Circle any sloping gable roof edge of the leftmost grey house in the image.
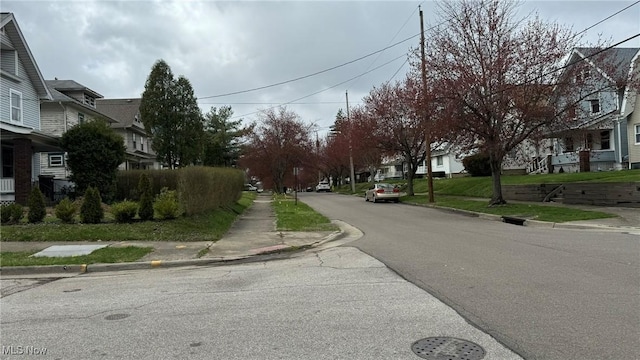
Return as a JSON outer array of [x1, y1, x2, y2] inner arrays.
[[0, 12, 51, 100]]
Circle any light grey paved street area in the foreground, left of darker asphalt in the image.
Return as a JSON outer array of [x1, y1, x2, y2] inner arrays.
[[0, 247, 519, 360]]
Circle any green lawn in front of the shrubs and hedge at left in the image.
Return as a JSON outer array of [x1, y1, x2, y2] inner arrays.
[[0, 192, 256, 241]]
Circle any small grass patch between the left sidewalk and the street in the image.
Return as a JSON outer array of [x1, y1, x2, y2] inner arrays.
[[272, 195, 338, 231]]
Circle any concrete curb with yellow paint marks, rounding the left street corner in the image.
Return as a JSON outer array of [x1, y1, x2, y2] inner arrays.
[[0, 230, 344, 276]]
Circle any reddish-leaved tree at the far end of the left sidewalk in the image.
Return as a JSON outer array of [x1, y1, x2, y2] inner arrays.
[[242, 107, 313, 193]]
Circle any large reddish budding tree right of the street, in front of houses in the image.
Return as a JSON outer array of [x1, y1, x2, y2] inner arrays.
[[426, 0, 578, 205]]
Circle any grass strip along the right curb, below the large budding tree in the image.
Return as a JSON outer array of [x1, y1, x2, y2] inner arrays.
[[401, 195, 615, 223]]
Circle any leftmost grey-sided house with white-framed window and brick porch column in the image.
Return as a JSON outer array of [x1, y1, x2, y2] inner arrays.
[[0, 13, 61, 205]]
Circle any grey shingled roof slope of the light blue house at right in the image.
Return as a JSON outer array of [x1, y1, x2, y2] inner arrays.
[[575, 47, 640, 82]]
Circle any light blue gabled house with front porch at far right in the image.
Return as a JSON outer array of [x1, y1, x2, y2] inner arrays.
[[528, 48, 640, 173]]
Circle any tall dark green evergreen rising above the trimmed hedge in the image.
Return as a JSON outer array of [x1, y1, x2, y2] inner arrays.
[[140, 60, 204, 168]]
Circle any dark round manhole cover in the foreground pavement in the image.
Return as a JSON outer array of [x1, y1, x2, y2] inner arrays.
[[411, 337, 485, 360]]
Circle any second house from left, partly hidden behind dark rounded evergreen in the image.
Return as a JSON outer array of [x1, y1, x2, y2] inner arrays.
[[38, 79, 116, 191]]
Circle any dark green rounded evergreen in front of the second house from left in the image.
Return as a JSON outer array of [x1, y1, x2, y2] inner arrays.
[[60, 120, 125, 201]]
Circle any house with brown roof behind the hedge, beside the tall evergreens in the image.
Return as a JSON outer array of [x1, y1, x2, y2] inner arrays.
[[96, 98, 161, 170]]
